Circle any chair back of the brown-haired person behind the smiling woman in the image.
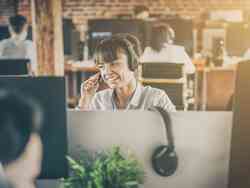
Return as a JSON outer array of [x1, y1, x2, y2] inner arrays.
[[139, 62, 187, 110]]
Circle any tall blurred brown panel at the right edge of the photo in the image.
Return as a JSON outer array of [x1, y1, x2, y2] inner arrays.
[[228, 61, 250, 188]]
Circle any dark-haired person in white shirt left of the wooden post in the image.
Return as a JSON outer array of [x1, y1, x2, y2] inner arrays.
[[0, 15, 37, 74]]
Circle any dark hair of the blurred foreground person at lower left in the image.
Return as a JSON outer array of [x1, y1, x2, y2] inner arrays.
[[0, 89, 42, 164]]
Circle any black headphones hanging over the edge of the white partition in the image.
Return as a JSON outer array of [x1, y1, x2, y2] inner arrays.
[[150, 107, 178, 177]]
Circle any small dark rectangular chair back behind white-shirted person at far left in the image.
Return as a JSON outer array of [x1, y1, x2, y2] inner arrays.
[[0, 59, 30, 76]]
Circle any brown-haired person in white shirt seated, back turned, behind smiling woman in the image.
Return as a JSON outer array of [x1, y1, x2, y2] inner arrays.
[[140, 24, 195, 74]]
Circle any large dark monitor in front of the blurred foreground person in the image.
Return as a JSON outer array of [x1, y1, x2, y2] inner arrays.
[[0, 77, 68, 179]]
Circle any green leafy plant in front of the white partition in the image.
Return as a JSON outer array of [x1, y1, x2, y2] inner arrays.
[[63, 147, 144, 188]]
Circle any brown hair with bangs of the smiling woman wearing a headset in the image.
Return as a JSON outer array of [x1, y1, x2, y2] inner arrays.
[[94, 36, 138, 71]]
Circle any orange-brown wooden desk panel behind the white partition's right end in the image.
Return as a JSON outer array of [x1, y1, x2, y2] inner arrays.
[[196, 67, 236, 110]]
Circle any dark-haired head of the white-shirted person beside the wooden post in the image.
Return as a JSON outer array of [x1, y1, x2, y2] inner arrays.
[[9, 15, 28, 41]]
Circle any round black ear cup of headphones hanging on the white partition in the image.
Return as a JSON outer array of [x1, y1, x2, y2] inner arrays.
[[152, 145, 178, 177]]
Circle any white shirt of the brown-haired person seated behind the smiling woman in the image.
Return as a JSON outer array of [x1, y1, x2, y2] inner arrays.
[[140, 43, 195, 74]]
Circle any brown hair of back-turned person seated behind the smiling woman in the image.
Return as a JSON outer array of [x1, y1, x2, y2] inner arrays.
[[150, 24, 174, 52]]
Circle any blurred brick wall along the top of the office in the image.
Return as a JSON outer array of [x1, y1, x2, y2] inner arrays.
[[0, 0, 250, 38]]
